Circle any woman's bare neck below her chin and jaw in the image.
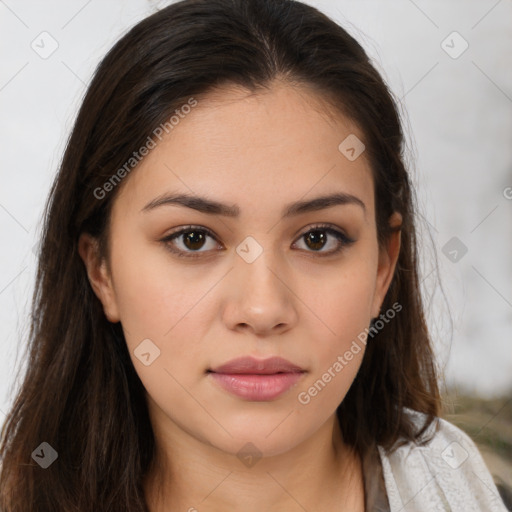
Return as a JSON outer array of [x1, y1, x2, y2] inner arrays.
[[145, 415, 364, 512]]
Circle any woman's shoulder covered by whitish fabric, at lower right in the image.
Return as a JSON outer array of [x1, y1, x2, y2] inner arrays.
[[379, 409, 507, 512]]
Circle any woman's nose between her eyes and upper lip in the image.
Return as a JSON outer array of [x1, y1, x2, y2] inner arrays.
[[223, 247, 298, 336]]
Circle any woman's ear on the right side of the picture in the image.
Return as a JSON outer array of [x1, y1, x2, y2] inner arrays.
[[372, 212, 402, 318]]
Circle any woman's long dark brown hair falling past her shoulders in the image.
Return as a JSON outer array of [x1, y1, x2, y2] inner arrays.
[[0, 0, 439, 512]]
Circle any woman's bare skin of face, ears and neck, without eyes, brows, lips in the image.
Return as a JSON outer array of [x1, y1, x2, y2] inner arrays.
[[79, 82, 400, 512]]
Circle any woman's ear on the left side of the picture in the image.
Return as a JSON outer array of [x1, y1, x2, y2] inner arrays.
[[78, 233, 119, 323]]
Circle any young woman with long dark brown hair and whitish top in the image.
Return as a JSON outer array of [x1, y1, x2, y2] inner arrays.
[[0, 0, 505, 512]]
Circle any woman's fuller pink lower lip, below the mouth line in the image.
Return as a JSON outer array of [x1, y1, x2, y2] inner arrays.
[[209, 372, 304, 402]]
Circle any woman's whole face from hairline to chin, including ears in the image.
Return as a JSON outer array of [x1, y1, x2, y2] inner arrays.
[[80, 85, 399, 455]]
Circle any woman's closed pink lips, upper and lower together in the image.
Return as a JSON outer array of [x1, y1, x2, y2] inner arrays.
[[208, 357, 305, 401]]
